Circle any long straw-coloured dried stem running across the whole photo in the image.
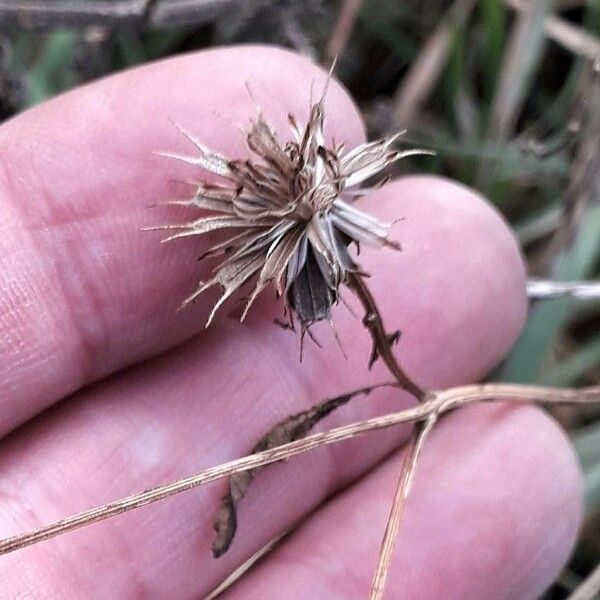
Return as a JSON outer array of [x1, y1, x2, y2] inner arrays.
[[0, 383, 600, 554]]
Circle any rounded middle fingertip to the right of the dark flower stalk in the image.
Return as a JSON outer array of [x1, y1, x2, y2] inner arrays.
[[361, 176, 527, 386]]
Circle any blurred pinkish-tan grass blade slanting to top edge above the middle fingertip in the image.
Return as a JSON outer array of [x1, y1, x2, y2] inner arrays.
[[393, 0, 475, 127]]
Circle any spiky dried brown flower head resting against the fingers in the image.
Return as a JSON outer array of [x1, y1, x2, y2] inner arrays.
[[157, 82, 421, 331]]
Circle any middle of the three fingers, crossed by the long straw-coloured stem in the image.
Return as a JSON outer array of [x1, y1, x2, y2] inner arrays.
[[0, 177, 525, 597]]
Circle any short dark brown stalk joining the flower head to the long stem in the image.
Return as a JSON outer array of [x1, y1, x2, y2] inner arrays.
[[348, 273, 427, 401]]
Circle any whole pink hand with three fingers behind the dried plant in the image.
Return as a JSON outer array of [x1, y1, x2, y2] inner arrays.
[[0, 47, 581, 600]]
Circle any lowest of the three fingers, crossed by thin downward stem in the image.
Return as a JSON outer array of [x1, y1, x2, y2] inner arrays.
[[224, 406, 582, 600]]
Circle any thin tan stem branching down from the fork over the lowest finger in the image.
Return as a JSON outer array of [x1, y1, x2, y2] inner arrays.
[[369, 412, 438, 600]]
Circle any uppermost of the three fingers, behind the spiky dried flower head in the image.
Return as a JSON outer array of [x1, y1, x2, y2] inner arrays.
[[0, 47, 363, 435]]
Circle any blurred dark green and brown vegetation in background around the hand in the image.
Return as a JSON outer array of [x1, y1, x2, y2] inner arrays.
[[0, 0, 600, 600]]
